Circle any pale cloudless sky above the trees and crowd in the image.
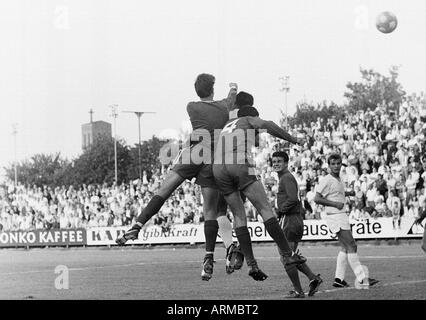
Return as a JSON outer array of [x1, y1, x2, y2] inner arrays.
[[0, 0, 426, 180]]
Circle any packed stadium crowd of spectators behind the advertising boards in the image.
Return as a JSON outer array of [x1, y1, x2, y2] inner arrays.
[[0, 93, 426, 231]]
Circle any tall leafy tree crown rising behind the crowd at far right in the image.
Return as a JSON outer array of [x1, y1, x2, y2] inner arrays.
[[344, 66, 406, 112]]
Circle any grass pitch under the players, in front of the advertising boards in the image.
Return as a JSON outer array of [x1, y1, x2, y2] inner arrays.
[[0, 240, 426, 301]]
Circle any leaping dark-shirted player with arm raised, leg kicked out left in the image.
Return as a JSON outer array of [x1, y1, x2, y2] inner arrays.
[[116, 73, 237, 281]]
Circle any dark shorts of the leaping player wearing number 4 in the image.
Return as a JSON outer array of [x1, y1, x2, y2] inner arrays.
[[213, 164, 258, 195]]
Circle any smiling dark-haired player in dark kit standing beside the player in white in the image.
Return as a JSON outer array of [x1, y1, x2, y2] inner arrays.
[[272, 151, 322, 298]]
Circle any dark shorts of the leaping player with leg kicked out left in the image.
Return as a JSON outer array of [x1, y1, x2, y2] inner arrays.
[[172, 149, 218, 189]]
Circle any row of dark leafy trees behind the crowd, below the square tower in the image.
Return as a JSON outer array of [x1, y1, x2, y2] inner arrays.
[[4, 136, 167, 186]]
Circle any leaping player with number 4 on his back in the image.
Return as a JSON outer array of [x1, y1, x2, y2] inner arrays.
[[213, 102, 306, 281]]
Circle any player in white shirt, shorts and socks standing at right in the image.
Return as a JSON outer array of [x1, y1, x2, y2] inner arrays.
[[314, 153, 379, 289]]
